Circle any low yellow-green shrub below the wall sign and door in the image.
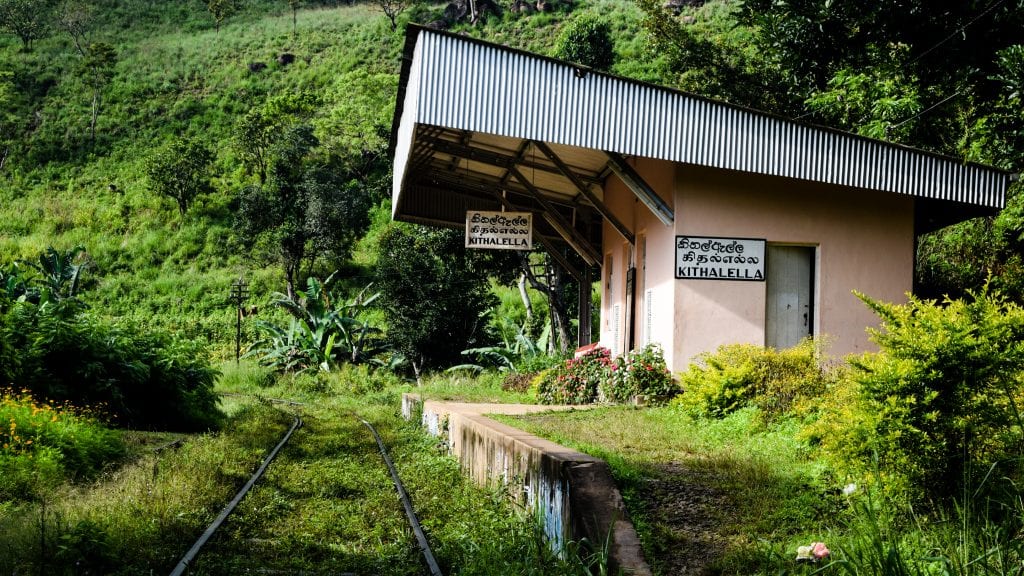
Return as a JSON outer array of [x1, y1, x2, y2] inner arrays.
[[677, 339, 830, 419]]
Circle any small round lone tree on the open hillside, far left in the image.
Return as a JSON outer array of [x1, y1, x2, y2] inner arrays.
[[145, 138, 213, 215]]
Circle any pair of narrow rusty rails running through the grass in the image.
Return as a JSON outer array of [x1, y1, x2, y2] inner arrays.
[[170, 399, 443, 576]]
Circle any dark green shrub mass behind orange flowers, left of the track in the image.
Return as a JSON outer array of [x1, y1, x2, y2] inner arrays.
[[0, 299, 223, 430]]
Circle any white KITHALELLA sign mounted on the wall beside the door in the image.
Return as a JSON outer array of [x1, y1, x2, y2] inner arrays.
[[676, 236, 765, 282]]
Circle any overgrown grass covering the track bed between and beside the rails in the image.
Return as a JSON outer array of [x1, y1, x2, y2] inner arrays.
[[0, 363, 587, 575]]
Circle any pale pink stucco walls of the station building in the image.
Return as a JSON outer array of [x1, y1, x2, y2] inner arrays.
[[600, 160, 913, 371]]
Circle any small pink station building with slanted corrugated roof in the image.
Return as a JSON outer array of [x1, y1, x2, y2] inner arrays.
[[392, 26, 1010, 371]]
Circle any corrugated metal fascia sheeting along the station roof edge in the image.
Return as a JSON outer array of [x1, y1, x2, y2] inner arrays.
[[393, 28, 1010, 208]]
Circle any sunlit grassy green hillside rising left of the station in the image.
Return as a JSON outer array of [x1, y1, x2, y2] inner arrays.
[[0, 2, 409, 352]]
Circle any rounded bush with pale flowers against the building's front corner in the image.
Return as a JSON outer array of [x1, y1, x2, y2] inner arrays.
[[601, 344, 679, 403]]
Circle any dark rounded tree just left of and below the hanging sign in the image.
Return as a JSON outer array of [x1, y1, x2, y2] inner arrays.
[[376, 223, 495, 381]]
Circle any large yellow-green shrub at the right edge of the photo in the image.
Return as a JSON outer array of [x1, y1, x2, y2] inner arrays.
[[805, 287, 1024, 498]]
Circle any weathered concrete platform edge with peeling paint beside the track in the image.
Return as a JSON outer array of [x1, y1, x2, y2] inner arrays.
[[402, 395, 650, 575]]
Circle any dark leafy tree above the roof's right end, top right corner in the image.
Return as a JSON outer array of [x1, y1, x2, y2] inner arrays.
[[738, 0, 1024, 154]]
